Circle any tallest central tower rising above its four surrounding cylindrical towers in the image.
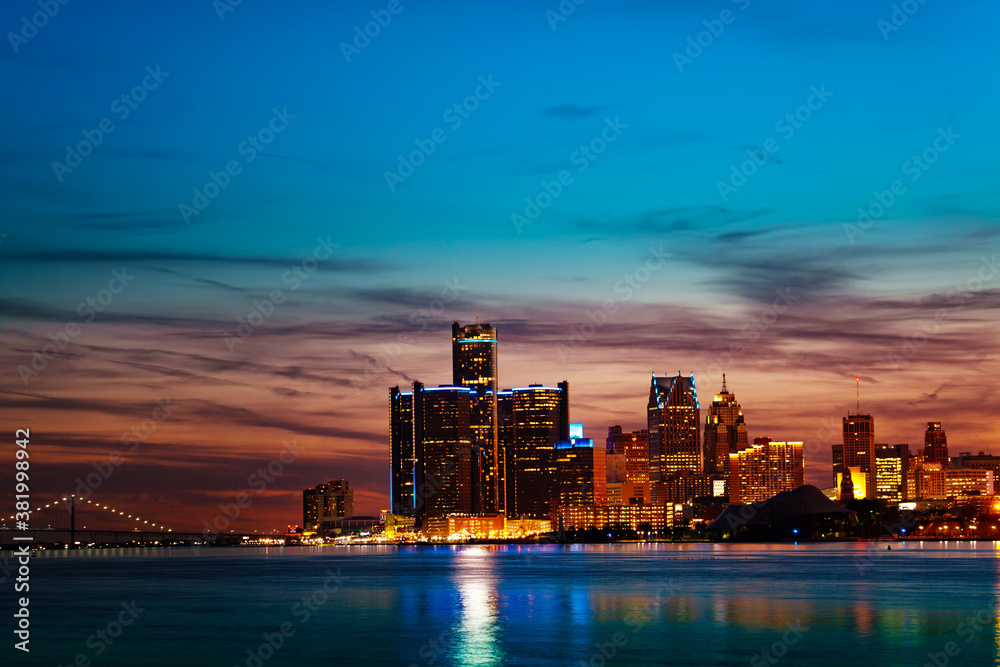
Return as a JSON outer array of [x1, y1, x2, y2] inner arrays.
[[451, 322, 503, 513]]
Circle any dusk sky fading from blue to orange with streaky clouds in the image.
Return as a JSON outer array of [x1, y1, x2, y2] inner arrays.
[[0, 0, 1000, 530]]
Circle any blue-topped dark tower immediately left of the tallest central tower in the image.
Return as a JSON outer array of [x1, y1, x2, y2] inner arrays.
[[413, 382, 474, 527]]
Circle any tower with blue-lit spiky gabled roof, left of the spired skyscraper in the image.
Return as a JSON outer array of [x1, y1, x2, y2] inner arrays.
[[646, 372, 702, 482]]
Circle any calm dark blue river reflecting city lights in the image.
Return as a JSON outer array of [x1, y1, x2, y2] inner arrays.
[[7, 542, 1000, 667]]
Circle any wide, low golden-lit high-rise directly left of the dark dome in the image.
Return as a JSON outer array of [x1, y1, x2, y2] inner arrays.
[[729, 438, 805, 503]]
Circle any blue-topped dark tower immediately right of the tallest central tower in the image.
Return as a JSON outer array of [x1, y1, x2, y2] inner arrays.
[[501, 382, 569, 519]]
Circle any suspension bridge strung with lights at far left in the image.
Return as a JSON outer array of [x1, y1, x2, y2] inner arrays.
[[0, 495, 213, 547]]
